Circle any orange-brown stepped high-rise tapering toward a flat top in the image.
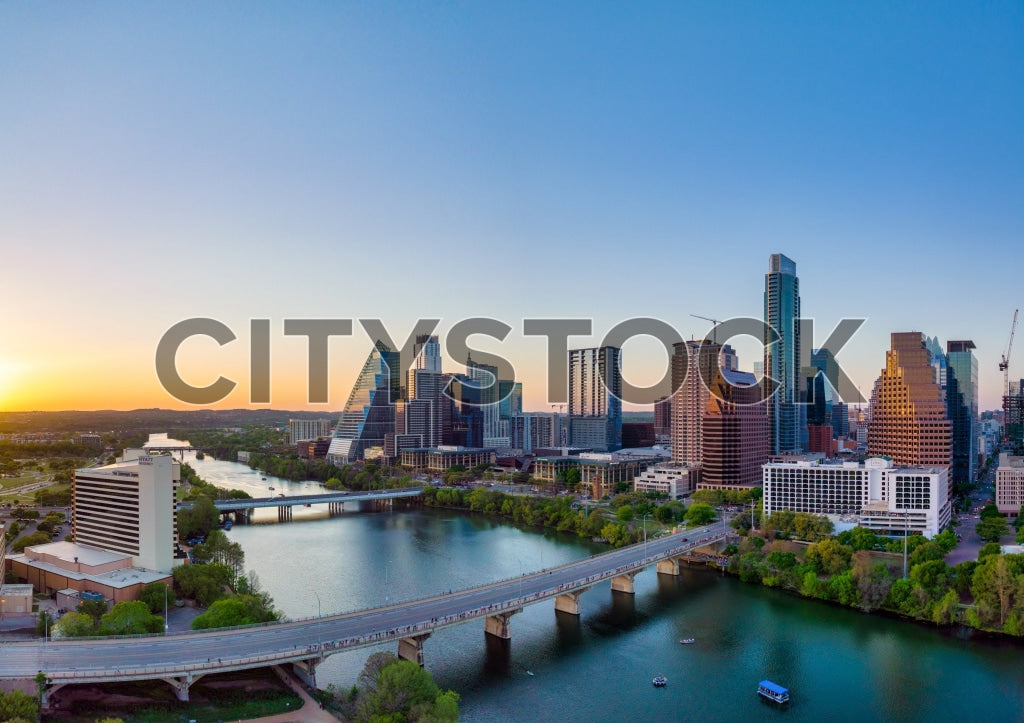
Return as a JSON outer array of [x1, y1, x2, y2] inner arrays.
[[867, 332, 952, 466]]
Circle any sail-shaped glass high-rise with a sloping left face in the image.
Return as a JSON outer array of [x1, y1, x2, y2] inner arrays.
[[327, 341, 404, 465]]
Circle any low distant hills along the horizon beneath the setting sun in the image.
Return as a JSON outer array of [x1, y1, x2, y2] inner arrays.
[[0, 409, 341, 432]]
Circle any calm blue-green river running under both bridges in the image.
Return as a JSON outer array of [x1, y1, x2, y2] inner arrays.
[[178, 454, 1024, 721]]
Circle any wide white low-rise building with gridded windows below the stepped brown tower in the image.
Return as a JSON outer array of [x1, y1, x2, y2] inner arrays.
[[762, 457, 950, 538]]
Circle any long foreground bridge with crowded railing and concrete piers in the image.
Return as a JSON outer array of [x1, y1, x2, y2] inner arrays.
[[0, 521, 730, 705]]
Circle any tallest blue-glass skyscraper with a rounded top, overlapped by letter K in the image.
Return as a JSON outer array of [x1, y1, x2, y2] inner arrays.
[[762, 254, 804, 455]]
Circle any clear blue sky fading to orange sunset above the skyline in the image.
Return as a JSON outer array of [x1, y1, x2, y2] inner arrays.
[[0, 1, 1024, 412]]
